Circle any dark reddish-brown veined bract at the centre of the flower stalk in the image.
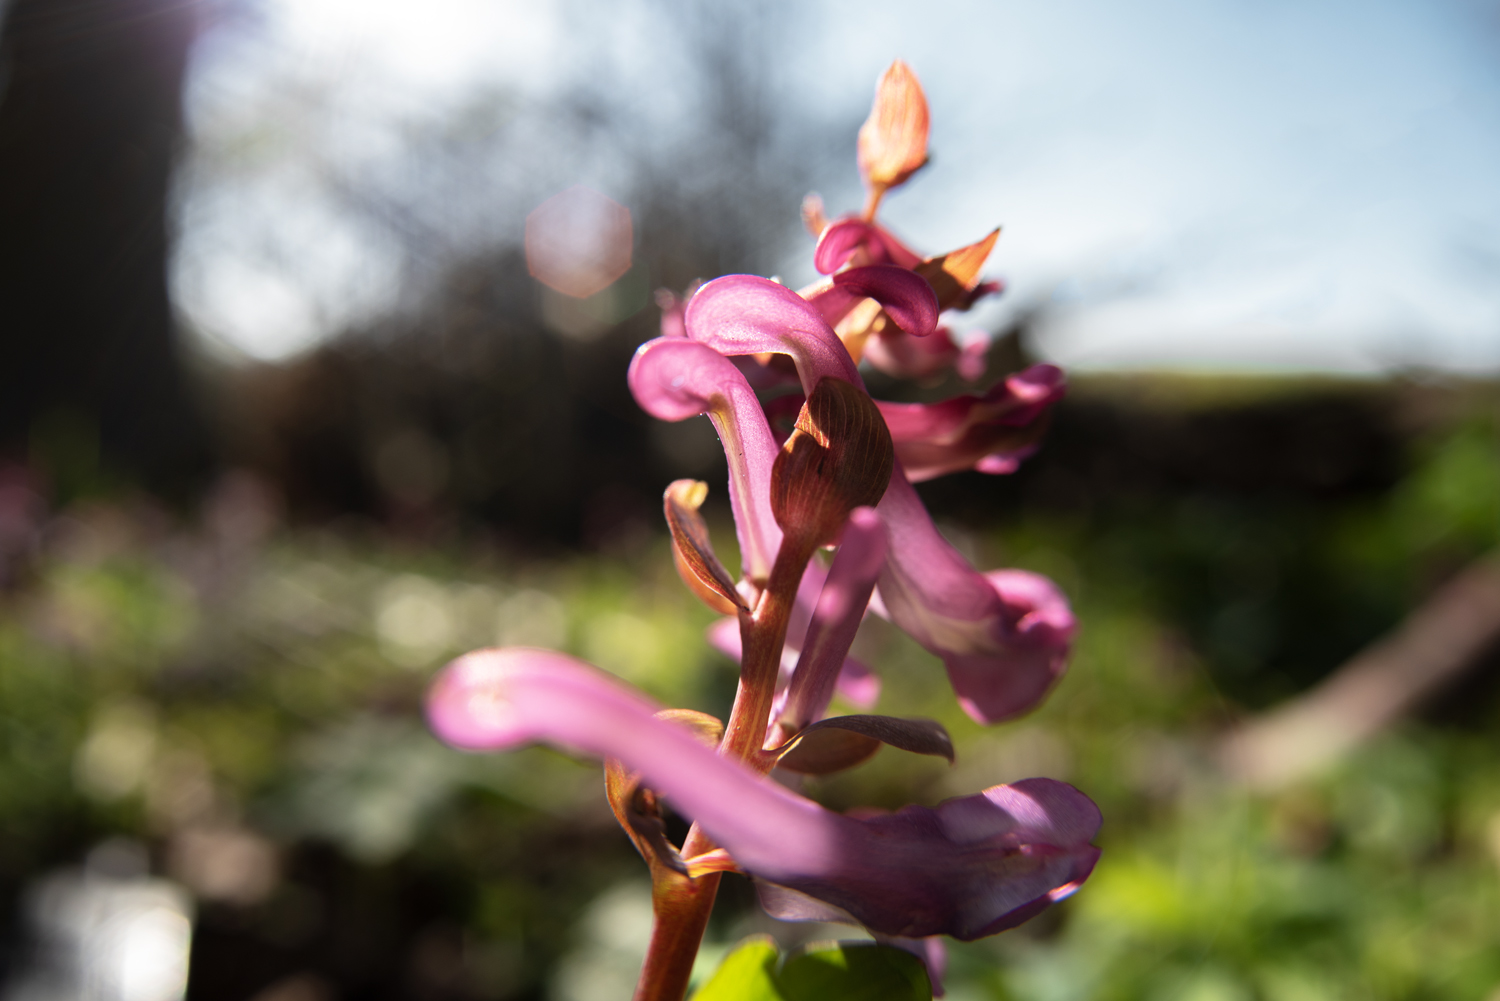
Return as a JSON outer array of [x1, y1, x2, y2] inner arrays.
[[771, 378, 896, 546]]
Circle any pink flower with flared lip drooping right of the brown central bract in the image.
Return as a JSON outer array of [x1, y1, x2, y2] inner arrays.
[[878, 464, 1076, 723]]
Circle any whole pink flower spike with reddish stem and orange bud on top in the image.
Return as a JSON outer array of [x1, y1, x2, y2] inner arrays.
[[429, 63, 1100, 998]]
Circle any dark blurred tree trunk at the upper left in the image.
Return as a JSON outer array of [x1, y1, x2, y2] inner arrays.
[[0, 0, 209, 491]]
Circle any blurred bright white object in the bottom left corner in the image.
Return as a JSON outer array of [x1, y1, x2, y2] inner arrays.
[[5, 842, 192, 1001]]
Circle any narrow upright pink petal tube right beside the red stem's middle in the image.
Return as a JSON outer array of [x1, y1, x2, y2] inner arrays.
[[780, 507, 887, 737]]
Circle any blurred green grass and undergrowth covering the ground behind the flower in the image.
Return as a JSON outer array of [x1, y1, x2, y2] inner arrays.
[[0, 379, 1500, 1001]]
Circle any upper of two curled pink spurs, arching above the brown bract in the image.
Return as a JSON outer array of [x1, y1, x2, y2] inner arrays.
[[686, 275, 864, 393]]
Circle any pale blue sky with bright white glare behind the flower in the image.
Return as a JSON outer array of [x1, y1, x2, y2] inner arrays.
[[179, 0, 1500, 372]]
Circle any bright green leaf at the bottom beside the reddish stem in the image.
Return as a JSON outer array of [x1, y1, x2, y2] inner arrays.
[[693, 935, 933, 1001]]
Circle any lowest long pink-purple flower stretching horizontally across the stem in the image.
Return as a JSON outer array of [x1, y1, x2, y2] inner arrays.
[[428, 648, 1100, 939]]
